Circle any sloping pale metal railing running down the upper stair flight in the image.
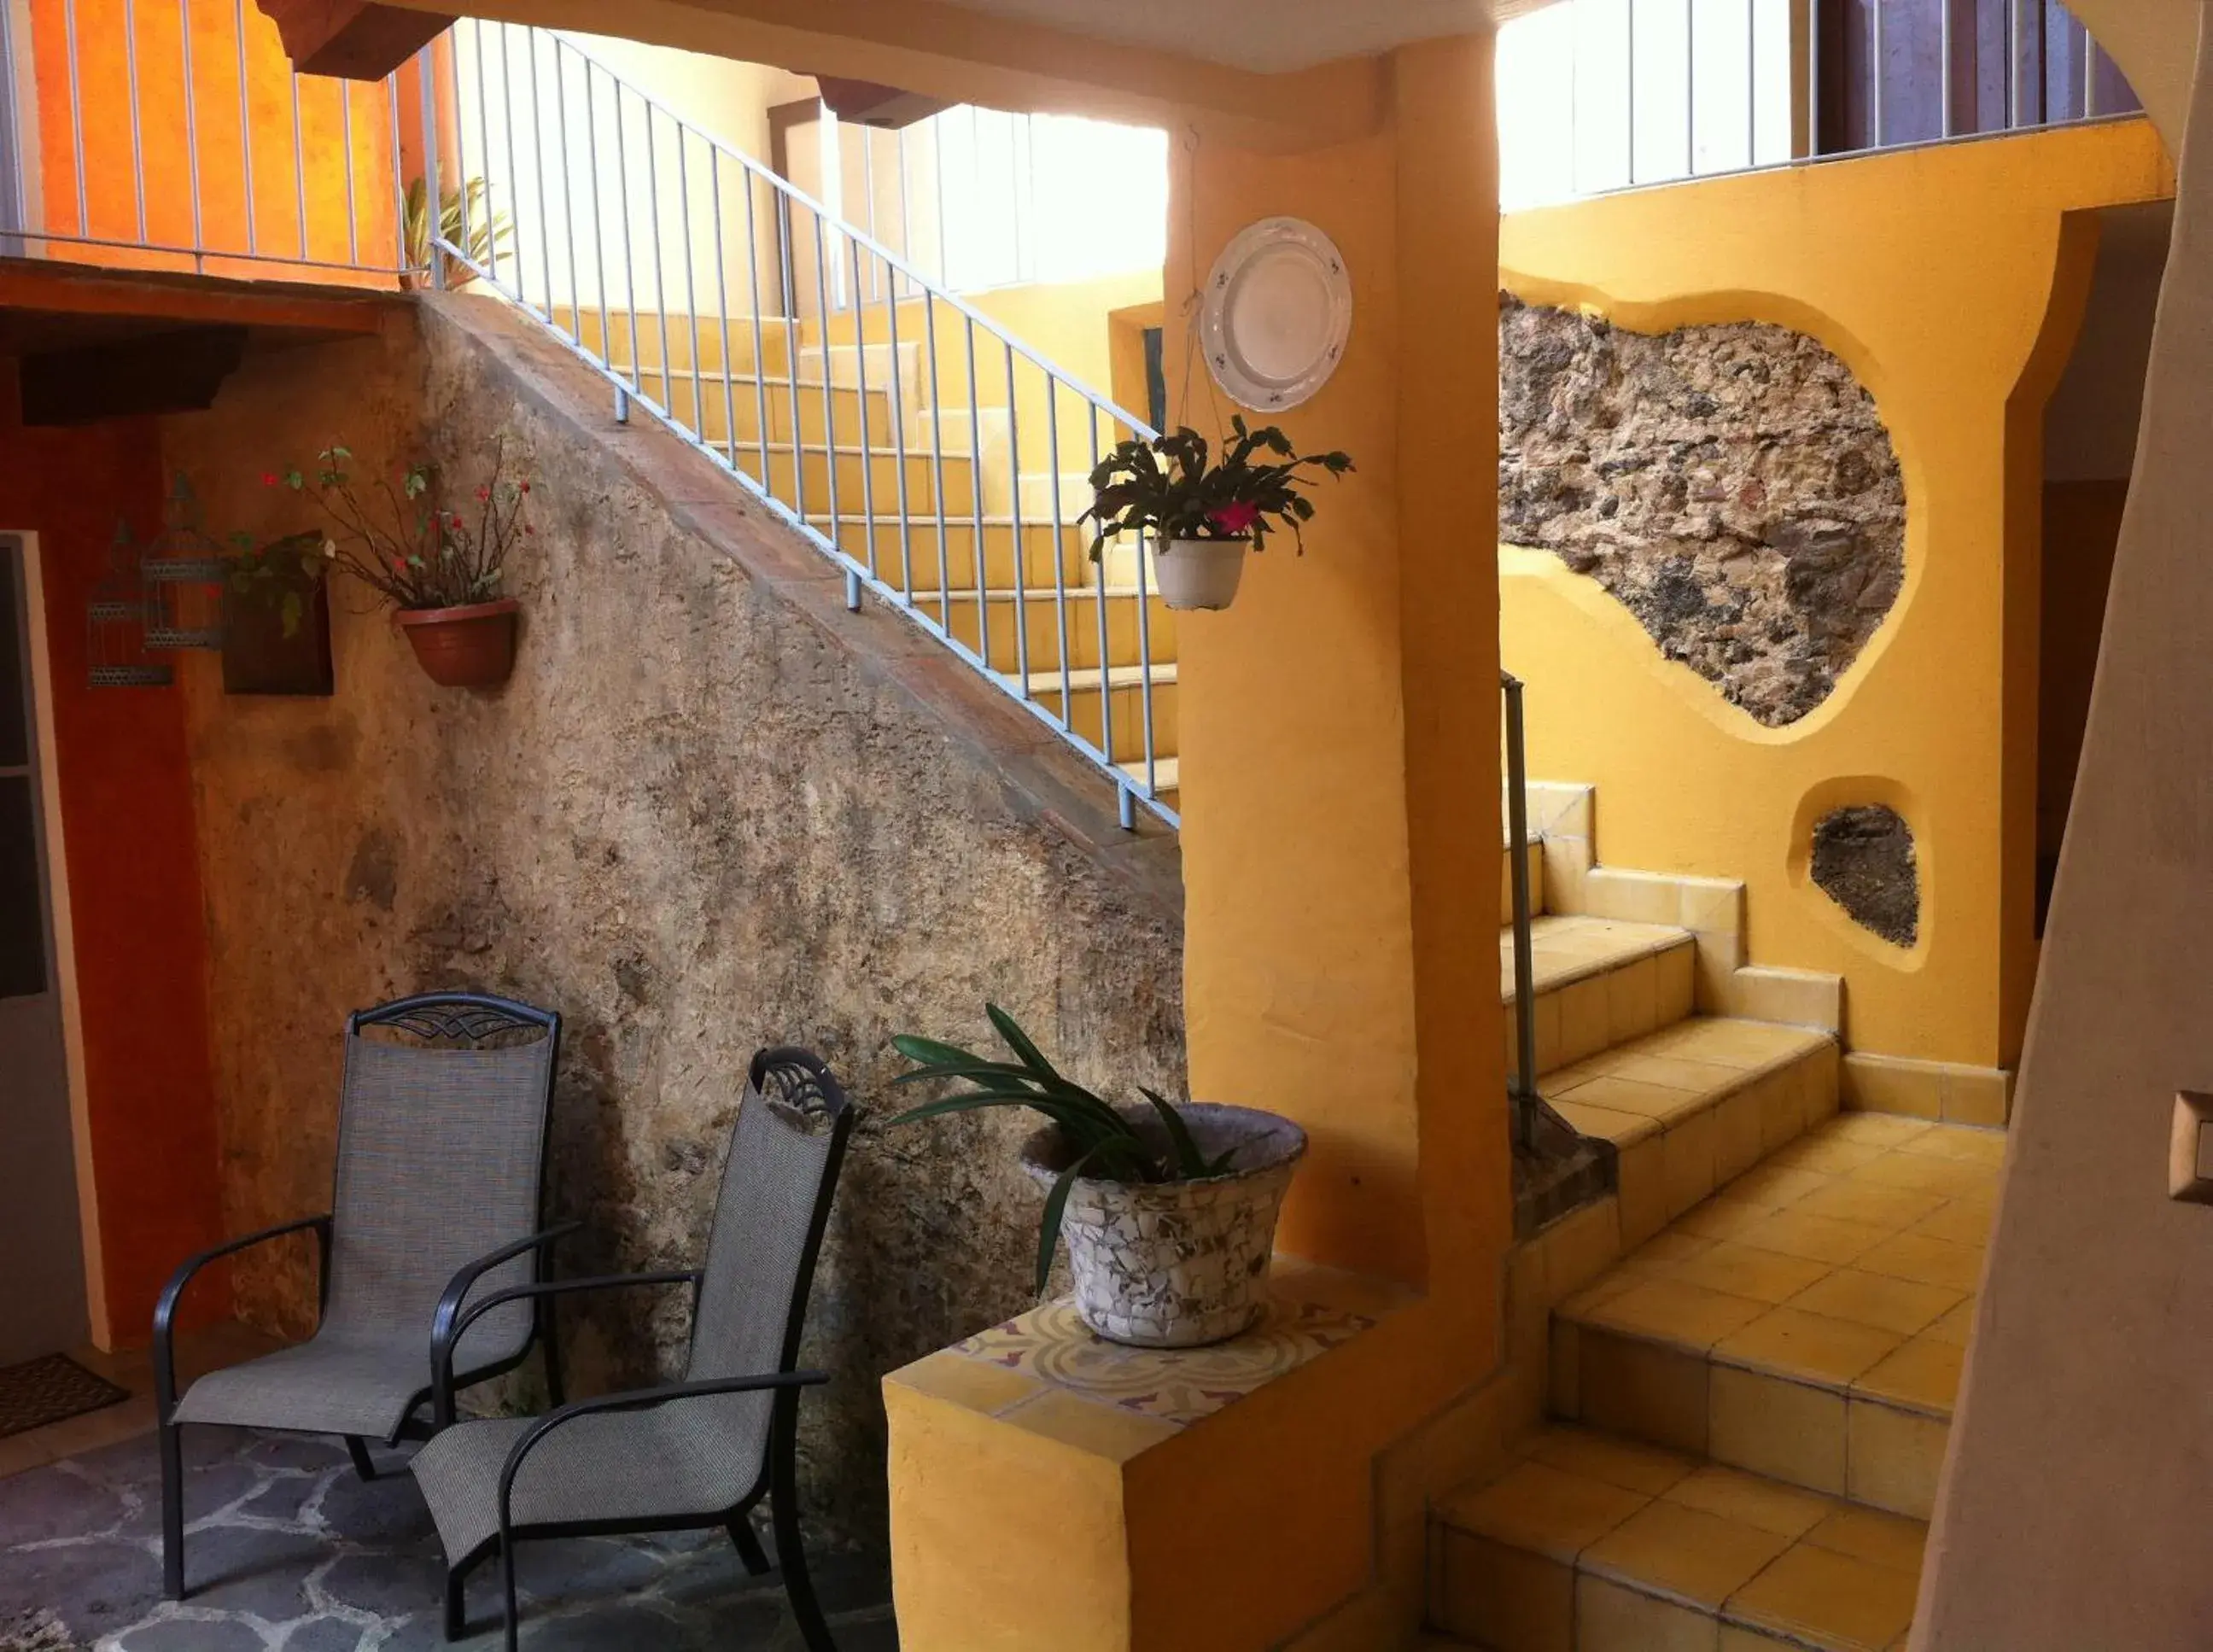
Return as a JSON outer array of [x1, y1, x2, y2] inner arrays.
[[423, 18, 1177, 825]]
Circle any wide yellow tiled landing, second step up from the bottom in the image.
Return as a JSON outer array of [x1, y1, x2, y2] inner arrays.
[[1551, 1112, 2005, 1520]]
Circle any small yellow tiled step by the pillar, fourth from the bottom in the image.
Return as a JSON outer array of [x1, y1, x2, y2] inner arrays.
[[1498, 915, 1695, 1079]]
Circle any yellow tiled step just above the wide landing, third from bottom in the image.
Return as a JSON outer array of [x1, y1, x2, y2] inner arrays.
[[1540, 1015, 1839, 1245]]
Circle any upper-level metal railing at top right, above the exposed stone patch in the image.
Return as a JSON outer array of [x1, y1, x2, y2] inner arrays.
[[1498, 0, 2138, 210]]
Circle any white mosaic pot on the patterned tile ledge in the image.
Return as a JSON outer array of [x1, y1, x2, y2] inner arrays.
[[1023, 1101, 1305, 1349]]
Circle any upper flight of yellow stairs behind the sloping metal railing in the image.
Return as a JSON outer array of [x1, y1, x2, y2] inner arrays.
[[556, 305, 1177, 807]]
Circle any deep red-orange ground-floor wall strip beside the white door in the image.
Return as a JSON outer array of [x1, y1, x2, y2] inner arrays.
[[0, 398, 228, 1347]]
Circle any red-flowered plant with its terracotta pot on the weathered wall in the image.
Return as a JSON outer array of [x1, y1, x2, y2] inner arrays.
[[274, 440, 535, 688]]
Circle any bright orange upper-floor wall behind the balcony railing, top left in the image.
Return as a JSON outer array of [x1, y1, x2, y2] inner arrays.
[[29, 0, 420, 281]]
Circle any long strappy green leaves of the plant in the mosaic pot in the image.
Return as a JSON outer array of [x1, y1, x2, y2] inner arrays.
[[890, 1004, 1237, 1292]]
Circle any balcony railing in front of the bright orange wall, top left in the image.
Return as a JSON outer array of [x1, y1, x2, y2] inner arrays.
[[0, 0, 416, 285]]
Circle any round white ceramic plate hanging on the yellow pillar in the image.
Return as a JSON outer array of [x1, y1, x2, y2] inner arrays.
[[1200, 219, 1352, 413]]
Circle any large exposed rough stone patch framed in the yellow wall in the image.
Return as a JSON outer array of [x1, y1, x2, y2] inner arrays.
[[1498, 295, 1906, 727]]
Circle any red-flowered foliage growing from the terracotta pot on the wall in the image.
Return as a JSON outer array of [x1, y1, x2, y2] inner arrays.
[[261, 440, 535, 608]]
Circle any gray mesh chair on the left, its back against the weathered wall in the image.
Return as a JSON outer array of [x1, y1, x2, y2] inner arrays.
[[153, 993, 578, 1599]]
